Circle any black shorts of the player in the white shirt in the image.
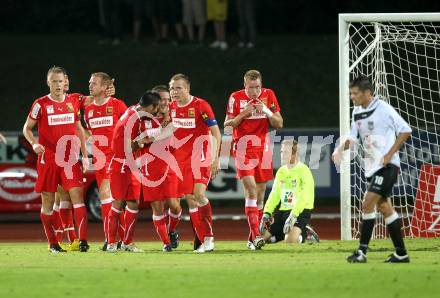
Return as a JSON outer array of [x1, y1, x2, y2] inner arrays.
[[367, 163, 399, 199]]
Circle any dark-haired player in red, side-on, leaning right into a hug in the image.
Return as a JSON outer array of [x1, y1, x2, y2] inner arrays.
[[107, 91, 160, 252]]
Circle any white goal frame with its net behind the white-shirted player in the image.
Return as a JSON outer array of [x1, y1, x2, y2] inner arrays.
[[339, 14, 440, 239]]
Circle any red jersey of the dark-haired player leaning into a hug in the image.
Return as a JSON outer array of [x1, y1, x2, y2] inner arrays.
[[111, 106, 142, 159]]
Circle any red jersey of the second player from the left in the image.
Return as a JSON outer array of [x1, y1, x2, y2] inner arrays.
[[84, 97, 127, 155]]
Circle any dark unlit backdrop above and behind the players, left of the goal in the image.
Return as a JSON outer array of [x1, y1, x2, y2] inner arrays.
[[0, 0, 440, 131]]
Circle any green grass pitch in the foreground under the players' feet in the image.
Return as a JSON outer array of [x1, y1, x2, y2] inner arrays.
[[0, 239, 440, 298]]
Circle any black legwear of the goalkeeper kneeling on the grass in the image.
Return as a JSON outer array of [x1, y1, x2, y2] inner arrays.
[[269, 209, 312, 243]]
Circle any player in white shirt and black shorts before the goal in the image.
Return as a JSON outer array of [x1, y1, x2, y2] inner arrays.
[[332, 76, 411, 263]]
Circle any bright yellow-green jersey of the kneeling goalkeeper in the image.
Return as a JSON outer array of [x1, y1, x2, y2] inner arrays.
[[264, 162, 315, 217]]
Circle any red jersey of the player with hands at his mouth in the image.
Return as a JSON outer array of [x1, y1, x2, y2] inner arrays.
[[226, 88, 280, 151]]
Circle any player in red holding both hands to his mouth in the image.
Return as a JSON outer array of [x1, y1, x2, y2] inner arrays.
[[224, 70, 283, 250]]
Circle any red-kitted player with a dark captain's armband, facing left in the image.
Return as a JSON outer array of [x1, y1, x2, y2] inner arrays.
[[169, 74, 221, 253]]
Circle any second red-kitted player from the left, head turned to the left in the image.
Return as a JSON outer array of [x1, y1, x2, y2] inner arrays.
[[84, 72, 127, 250]]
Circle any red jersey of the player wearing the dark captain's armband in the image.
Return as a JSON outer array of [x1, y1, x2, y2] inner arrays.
[[170, 96, 217, 162]]
